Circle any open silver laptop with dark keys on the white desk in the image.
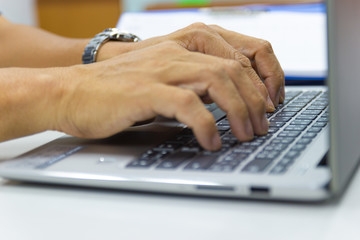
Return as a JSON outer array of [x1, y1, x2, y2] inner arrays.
[[0, 0, 360, 202]]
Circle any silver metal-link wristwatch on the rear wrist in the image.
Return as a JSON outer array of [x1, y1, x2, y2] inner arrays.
[[82, 28, 141, 64]]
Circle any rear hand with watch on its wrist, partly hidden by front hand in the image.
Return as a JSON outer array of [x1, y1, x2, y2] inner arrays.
[[98, 23, 285, 112]]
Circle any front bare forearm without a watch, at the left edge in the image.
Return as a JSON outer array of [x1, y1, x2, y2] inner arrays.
[[0, 68, 63, 141]]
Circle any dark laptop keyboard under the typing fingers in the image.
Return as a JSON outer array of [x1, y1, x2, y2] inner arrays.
[[127, 91, 328, 174]]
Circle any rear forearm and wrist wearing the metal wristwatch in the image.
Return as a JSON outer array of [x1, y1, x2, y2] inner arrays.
[[0, 16, 132, 67]]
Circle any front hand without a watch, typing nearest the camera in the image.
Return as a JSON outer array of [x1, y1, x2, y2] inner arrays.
[[54, 40, 268, 150]]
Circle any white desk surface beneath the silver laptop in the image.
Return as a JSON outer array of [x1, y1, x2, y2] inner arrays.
[[0, 132, 360, 240]]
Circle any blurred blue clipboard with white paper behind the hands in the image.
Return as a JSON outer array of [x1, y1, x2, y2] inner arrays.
[[117, 3, 328, 85]]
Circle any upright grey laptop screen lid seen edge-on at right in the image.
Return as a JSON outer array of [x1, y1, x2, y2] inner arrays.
[[328, 0, 360, 195]]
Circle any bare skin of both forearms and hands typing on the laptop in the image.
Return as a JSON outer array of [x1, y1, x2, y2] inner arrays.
[[0, 18, 285, 150]]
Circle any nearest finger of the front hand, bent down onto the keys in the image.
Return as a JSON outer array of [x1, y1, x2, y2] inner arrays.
[[150, 84, 221, 150]]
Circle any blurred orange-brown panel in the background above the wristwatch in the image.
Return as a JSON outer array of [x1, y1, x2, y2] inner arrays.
[[37, 0, 122, 37]]
